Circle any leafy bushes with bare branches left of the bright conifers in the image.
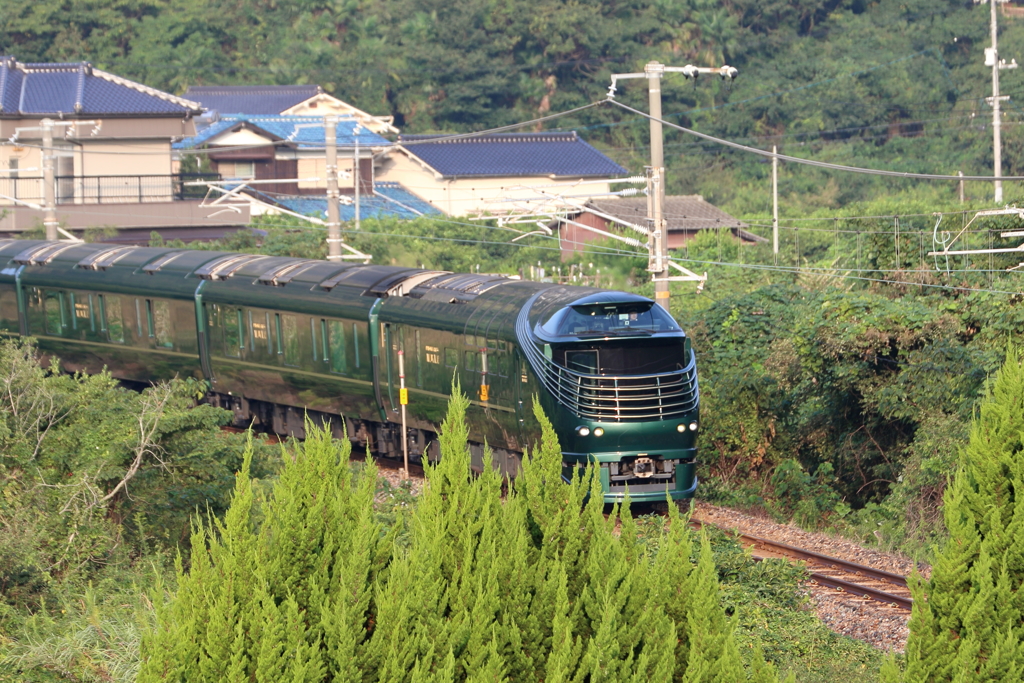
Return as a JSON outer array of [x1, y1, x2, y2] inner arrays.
[[0, 339, 276, 681]]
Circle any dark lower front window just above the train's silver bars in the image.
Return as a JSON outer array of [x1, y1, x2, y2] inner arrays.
[[552, 338, 690, 376]]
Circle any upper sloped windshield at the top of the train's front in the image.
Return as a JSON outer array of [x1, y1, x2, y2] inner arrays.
[[543, 301, 681, 337]]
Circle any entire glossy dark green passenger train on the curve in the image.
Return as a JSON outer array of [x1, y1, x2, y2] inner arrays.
[[0, 240, 699, 502]]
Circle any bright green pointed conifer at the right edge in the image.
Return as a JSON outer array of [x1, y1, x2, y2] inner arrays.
[[890, 349, 1024, 683]]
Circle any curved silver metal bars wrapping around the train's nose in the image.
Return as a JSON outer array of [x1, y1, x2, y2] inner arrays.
[[515, 295, 700, 422]]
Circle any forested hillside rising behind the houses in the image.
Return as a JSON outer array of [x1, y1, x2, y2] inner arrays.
[[0, 0, 1024, 211]]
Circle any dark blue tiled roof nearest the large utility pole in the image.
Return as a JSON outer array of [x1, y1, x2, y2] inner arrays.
[[399, 131, 627, 177]]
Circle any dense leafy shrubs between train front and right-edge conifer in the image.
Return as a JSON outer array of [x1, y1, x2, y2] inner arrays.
[[673, 216, 1024, 548]]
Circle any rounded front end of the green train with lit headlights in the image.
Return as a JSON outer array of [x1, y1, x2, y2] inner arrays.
[[516, 288, 699, 503]]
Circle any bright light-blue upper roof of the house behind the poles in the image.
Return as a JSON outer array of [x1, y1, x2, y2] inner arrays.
[[173, 116, 391, 150]]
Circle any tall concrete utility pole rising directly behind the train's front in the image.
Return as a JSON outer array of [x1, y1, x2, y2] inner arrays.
[[608, 61, 739, 310]]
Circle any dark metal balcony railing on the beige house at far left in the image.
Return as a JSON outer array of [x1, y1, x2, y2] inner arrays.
[[0, 173, 220, 206]]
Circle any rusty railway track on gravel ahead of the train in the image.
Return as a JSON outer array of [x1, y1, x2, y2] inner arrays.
[[690, 519, 913, 609]]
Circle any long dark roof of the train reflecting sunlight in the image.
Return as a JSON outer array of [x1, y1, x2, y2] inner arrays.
[[0, 240, 663, 336]]
